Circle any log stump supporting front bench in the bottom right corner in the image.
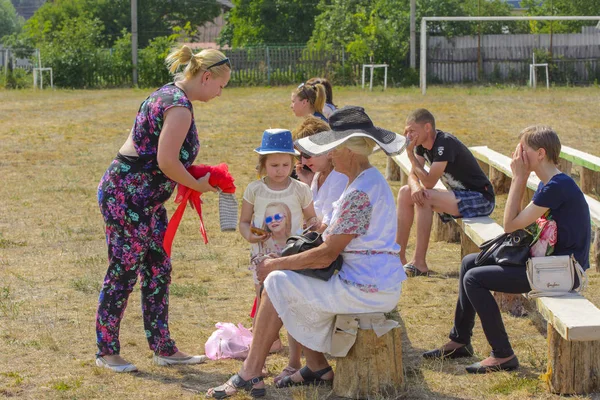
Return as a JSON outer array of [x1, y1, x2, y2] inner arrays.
[[543, 323, 600, 394]]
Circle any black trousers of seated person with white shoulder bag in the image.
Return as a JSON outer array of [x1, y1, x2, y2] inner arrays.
[[449, 253, 531, 358]]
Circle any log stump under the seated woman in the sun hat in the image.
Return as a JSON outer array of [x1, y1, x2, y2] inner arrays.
[[333, 328, 404, 399]]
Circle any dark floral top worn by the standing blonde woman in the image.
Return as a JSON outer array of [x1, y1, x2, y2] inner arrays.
[[133, 83, 200, 170]]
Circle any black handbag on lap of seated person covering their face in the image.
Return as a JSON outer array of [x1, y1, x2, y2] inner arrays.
[[475, 229, 533, 267]]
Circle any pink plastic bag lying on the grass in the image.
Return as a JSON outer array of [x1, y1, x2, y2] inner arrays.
[[204, 322, 252, 360]]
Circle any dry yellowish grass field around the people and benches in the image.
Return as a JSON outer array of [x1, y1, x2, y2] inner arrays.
[[0, 83, 600, 399]]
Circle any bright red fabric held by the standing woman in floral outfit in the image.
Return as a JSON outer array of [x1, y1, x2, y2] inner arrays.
[[163, 163, 235, 257]]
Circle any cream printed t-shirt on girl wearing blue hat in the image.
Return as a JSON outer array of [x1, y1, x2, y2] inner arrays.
[[244, 178, 312, 256]]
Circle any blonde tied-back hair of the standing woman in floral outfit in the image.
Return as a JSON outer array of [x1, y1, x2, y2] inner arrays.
[[165, 45, 230, 80]]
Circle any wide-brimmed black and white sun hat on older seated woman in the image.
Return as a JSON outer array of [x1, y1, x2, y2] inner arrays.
[[295, 106, 406, 156]]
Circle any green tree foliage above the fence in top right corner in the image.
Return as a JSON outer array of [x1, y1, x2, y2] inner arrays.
[[522, 0, 600, 33]]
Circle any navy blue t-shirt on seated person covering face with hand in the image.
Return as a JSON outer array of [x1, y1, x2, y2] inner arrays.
[[533, 173, 592, 269]]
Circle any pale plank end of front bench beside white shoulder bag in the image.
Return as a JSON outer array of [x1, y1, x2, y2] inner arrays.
[[535, 293, 600, 341]]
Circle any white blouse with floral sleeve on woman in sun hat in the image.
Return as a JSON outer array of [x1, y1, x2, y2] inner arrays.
[[325, 167, 406, 292]]
